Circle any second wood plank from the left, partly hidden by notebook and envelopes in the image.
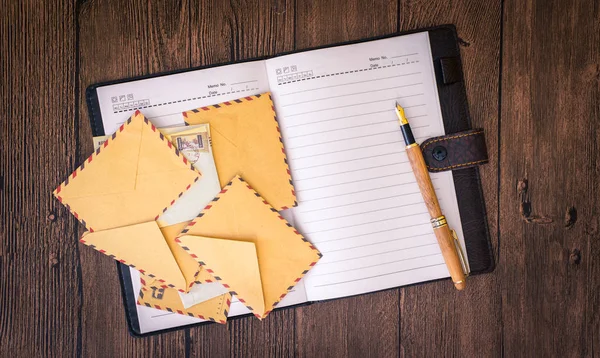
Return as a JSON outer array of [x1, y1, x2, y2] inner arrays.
[[77, 0, 190, 356]]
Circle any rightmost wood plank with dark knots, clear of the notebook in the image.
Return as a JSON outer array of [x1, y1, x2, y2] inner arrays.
[[499, 0, 600, 357]]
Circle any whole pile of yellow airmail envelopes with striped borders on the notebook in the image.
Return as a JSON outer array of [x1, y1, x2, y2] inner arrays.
[[54, 94, 321, 323]]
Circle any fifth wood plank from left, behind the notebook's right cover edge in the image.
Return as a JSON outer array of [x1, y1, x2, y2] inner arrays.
[[399, 0, 502, 357]]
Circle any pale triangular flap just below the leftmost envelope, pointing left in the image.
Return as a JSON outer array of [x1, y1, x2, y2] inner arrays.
[[80, 221, 187, 291]]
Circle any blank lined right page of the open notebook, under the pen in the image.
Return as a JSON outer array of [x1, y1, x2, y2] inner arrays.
[[266, 32, 462, 300]]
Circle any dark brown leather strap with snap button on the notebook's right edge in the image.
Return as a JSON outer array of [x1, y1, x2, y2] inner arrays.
[[421, 129, 488, 172]]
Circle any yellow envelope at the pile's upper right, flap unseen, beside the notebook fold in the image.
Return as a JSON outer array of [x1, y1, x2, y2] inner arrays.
[[183, 93, 297, 210]]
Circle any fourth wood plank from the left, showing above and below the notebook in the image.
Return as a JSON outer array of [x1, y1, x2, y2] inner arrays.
[[296, 0, 399, 357]]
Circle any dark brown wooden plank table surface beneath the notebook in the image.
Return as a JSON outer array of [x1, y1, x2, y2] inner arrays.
[[0, 0, 600, 357]]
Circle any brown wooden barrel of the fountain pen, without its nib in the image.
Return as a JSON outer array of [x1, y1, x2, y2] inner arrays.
[[406, 144, 466, 290]]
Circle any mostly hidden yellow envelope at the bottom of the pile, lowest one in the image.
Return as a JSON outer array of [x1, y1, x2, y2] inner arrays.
[[137, 286, 231, 324]]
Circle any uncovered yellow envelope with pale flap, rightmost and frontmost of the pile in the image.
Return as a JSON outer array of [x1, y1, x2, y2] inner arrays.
[[175, 176, 321, 319]]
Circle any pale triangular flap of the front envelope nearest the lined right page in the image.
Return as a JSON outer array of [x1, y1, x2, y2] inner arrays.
[[178, 235, 265, 316]]
